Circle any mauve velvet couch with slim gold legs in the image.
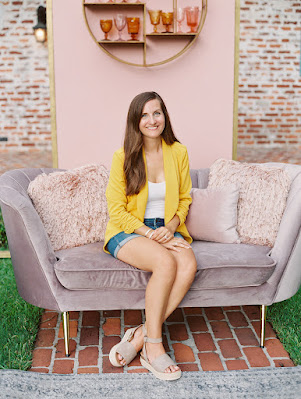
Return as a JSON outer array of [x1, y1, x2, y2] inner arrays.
[[0, 163, 301, 356]]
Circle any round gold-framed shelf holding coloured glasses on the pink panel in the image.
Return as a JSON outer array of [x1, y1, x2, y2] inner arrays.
[[83, 0, 207, 67]]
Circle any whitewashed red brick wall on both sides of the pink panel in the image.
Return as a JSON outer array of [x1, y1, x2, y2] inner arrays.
[[0, 0, 301, 150]]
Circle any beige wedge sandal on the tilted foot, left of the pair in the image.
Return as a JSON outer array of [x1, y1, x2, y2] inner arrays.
[[109, 324, 143, 367]]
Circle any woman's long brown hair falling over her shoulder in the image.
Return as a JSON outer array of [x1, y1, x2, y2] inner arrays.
[[123, 91, 179, 195]]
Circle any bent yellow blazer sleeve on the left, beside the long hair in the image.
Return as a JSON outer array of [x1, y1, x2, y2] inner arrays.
[[106, 152, 144, 234]]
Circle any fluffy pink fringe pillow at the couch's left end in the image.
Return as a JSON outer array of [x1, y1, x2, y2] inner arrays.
[[28, 165, 109, 251]]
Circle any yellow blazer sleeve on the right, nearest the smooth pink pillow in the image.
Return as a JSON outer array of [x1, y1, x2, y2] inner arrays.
[[176, 149, 192, 225]]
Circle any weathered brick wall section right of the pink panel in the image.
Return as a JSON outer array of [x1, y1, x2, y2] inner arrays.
[[238, 0, 301, 147]]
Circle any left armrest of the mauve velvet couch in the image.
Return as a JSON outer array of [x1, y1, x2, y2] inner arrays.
[[0, 174, 61, 310]]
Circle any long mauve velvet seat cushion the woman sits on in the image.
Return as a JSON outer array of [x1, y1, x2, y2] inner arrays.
[[54, 241, 275, 290]]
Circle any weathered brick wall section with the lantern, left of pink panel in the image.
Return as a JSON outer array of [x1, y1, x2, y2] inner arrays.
[[0, 0, 51, 150]]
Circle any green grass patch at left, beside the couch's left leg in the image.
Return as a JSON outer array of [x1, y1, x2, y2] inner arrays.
[[0, 259, 43, 372]]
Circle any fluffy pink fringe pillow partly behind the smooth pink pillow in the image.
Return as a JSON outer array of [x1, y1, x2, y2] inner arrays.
[[208, 159, 291, 247]]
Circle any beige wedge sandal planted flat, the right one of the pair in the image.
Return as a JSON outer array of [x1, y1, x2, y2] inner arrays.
[[140, 326, 182, 381]]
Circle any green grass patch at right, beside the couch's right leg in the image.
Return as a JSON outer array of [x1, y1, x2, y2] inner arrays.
[[267, 288, 301, 365]]
